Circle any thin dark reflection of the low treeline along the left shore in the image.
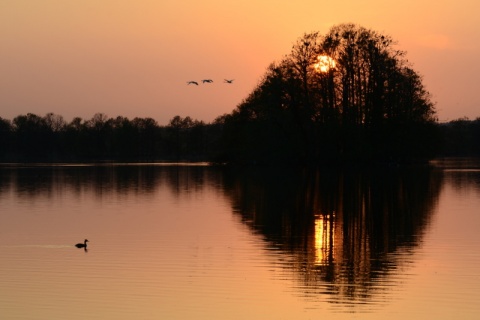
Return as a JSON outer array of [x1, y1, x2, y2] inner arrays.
[[0, 164, 221, 200]]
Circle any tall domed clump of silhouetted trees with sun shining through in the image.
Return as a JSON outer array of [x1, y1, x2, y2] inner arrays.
[[219, 24, 436, 163]]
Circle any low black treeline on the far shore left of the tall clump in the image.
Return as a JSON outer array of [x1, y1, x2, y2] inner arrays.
[[0, 113, 222, 162]]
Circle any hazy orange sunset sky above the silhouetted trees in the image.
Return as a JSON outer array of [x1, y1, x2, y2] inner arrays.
[[0, 0, 480, 125]]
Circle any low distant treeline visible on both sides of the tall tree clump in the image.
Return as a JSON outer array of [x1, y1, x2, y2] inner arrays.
[[0, 113, 480, 162]]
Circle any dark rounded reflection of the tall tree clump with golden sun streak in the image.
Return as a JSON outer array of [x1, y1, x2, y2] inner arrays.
[[226, 167, 442, 303]]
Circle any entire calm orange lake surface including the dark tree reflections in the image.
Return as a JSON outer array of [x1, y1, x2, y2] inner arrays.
[[0, 161, 480, 320]]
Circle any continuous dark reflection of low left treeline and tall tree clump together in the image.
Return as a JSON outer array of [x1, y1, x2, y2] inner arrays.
[[0, 165, 443, 304]]
